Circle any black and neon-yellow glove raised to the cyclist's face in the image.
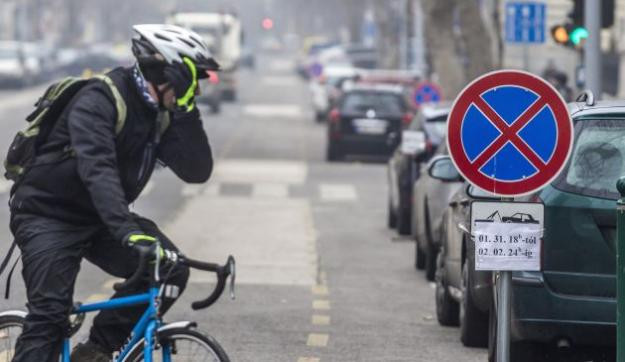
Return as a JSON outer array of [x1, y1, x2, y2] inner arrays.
[[163, 58, 198, 112]]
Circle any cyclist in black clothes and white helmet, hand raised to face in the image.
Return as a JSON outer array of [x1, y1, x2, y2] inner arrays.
[[10, 25, 219, 362]]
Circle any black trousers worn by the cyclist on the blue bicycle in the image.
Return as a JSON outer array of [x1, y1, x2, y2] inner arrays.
[[11, 216, 189, 362]]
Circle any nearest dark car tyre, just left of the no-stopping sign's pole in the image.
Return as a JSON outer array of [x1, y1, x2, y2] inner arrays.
[[460, 258, 488, 347]]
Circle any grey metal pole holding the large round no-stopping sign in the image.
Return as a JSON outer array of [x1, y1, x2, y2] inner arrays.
[[497, 197, 514, 362]]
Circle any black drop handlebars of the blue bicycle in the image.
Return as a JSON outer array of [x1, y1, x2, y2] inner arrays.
[[113, 244, 236, 310]]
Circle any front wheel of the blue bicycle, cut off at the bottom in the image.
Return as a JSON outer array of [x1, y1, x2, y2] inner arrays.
[[124, 328, 230, 362]]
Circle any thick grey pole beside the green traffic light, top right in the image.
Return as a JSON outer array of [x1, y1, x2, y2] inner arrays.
[[584, 1, 602, 99]]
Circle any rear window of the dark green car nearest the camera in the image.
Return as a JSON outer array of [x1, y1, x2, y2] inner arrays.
[[554, 119, 625, 199]]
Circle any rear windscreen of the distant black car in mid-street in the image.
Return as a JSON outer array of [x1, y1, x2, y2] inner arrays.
[[341, 92, 404, 115]]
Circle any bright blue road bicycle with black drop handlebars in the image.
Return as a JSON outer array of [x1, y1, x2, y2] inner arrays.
[[0, 245, 235, 362]]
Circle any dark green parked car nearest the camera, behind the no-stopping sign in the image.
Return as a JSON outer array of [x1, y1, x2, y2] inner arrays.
[[489, 97, 625, 361]]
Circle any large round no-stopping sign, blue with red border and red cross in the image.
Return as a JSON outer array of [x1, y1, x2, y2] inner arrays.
[[447, 70, 573, 196]]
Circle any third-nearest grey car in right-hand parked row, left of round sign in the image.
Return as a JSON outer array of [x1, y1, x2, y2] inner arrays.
[[412, 141, 462, 280]]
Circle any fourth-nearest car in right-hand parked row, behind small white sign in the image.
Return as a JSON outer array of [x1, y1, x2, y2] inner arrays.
[[388, 103, 450, 235]]
